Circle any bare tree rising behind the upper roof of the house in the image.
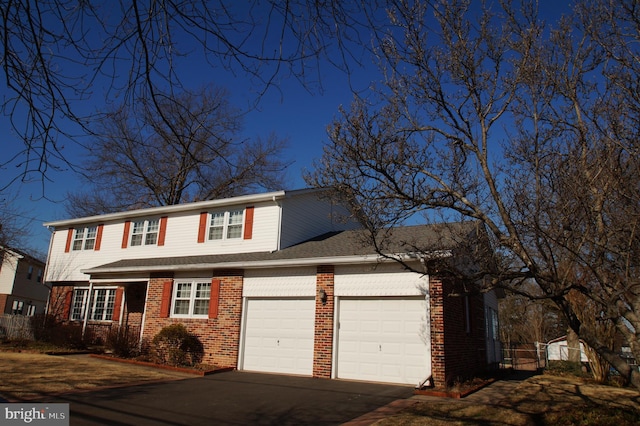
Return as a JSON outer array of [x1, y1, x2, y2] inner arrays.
[[67, 88, 288, 216]]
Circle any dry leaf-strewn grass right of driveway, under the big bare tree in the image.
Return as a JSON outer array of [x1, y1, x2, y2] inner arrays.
[[376, 375, 640, 426]]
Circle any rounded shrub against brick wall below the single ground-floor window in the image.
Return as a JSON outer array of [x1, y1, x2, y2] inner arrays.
[[151, 324, 204, 366]]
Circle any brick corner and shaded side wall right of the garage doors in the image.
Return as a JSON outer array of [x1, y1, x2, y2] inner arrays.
[[429, 278, 487, 386]]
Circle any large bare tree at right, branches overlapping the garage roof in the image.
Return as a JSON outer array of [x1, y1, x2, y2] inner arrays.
[[307, 0, 640, 388]]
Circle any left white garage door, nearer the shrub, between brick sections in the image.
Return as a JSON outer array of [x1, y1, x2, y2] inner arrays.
[[243, 299, 315, 375]]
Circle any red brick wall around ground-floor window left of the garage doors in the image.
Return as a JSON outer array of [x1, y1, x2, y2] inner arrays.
[[143, 270, 243, 367]]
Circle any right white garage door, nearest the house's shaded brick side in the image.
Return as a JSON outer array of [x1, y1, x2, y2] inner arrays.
[[336, 297, 431, 385]]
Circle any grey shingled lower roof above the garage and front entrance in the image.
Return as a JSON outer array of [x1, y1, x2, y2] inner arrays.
[[82, 222, 477, 274]]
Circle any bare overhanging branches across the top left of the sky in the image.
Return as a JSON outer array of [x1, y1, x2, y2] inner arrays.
[[0, 0, 367, 190]]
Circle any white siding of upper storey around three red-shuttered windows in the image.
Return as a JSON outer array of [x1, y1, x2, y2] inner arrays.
[[45, 193, 356, 282]]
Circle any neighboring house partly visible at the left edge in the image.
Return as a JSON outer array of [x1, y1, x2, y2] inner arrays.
[[0, 247, 49, 316]]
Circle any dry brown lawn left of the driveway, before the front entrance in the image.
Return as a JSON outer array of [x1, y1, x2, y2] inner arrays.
[[0, 352, 193, 400]]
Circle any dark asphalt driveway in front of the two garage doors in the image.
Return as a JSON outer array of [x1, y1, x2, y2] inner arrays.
[[47, 371, 413, 426]]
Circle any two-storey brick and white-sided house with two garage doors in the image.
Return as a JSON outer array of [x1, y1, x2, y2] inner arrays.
[[45, 190, 500, 385]]
